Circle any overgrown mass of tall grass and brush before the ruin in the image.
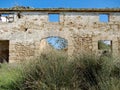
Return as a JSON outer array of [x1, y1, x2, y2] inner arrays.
[[0, 54, 120, 90]]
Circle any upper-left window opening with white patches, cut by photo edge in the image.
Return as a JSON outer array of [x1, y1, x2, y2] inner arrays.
[[0, 13, 14, 23]]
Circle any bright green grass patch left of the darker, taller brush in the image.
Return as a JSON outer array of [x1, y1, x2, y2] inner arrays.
[[0, 64, 22, 90]]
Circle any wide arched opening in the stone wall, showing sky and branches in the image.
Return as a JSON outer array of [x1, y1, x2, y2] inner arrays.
[[39, 36, 68, 56]]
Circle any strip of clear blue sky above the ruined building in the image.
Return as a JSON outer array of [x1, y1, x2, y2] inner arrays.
[[0, 0, 120, 8]]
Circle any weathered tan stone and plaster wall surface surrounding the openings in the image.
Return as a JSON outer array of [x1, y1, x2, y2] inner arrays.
[[0, 12, 120, 62]]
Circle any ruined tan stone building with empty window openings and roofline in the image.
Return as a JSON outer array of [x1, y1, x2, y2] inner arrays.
[[0, 8, 120, 62]]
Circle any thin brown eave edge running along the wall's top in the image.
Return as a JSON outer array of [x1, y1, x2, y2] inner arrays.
[[0, 8, 120, 13]]
